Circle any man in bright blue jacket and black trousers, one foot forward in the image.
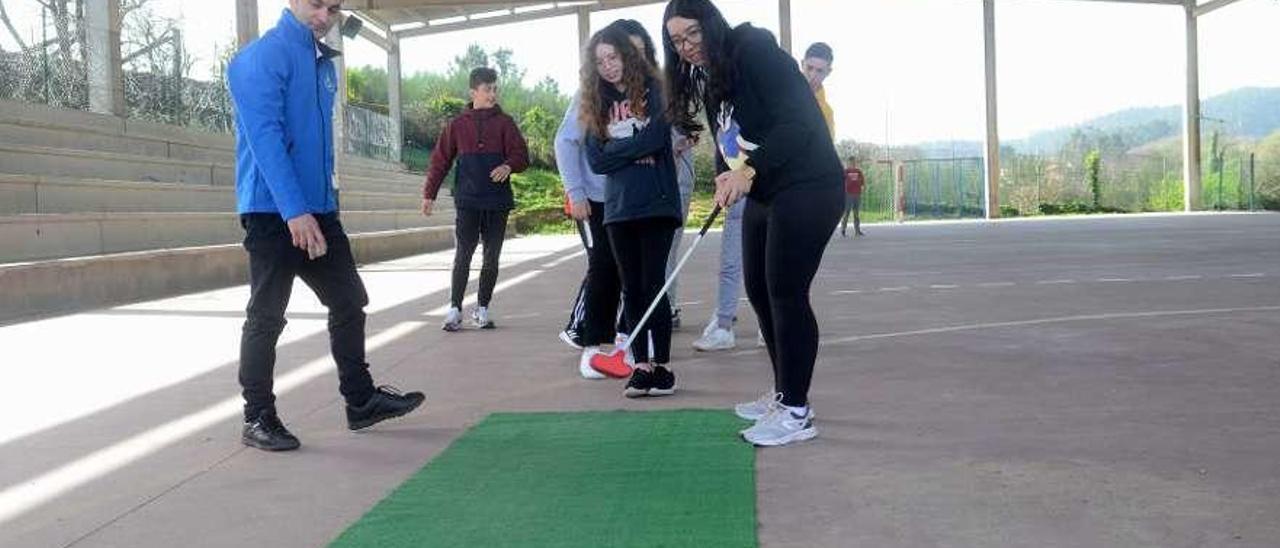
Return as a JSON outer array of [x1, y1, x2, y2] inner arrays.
[[228, 0, 425, 451]]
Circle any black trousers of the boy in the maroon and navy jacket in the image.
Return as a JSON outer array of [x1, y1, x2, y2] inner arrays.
[[449, 207, 511, 310]]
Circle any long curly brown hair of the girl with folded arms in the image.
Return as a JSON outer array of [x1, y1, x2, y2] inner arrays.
[[577, 24, 660, 140]]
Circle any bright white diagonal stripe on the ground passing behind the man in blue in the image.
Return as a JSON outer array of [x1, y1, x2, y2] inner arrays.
[[0, 321, 424, 524]]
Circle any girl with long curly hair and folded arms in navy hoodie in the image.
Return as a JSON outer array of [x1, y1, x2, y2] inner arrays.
[[580, 26, 681, 397]]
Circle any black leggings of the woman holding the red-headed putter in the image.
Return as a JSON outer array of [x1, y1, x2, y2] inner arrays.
[[742, 184, 845, 407]]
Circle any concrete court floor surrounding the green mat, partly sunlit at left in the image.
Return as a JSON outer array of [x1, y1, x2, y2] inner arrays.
[[0, 214, 1280, 548]]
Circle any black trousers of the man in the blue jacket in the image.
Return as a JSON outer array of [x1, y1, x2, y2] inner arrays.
[[239, 213, 374, 420]]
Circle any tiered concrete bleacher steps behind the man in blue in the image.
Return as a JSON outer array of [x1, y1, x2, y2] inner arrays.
[[0, 101, 453, 321]]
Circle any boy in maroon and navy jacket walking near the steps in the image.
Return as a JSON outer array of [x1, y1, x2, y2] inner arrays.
[[422, 67, 529, 332]]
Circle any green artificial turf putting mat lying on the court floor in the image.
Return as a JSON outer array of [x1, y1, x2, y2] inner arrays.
[[333, 410, 756, 548]]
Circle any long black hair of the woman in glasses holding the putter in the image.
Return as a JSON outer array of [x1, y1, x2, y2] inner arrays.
[[662, 0, 733, 134]]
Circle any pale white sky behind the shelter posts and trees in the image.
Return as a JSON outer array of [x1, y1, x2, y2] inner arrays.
[[0, 0, 1280, 143]]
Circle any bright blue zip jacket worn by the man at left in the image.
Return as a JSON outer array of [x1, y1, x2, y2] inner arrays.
[[227, 9, 338, 220]]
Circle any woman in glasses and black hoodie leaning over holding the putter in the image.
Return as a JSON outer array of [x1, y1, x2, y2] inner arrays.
[[663, 0, 844, 446]]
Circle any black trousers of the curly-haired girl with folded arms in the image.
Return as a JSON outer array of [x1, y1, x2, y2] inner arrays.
[[596, 219, 675, 364]]
